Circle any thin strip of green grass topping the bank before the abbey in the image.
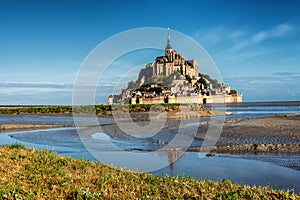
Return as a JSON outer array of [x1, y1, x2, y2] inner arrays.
[[0, 103, 192, 115]]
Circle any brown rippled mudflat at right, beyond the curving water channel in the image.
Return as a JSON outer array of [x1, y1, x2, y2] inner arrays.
[[195, 113, 300, 153]]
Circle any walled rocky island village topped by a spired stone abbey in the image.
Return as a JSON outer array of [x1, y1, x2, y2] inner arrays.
[[108, 31, 242, 104]]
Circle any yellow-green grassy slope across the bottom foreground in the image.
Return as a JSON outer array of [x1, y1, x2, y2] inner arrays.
[[0, 144, 300, 199]]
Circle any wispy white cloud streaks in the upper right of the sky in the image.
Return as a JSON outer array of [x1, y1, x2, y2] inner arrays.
[[193, 22, 299, 60]]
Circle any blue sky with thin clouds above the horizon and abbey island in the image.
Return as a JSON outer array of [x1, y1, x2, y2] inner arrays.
[[0, 0, 300, 105]]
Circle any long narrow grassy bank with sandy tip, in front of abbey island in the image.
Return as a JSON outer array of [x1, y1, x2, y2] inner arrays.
[[0, 103, 220, 118]]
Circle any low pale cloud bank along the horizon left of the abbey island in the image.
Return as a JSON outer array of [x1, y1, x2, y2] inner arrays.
[[0, 81, 116, 105]]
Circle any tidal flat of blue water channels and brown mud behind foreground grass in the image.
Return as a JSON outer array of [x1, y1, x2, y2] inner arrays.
[[0, 106, 300, 193]]
